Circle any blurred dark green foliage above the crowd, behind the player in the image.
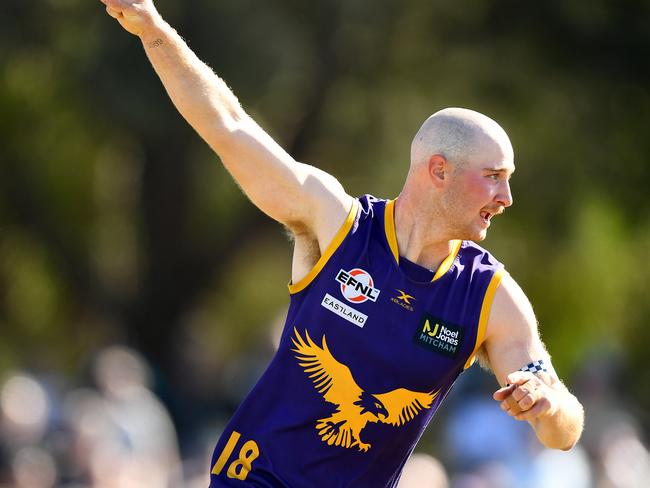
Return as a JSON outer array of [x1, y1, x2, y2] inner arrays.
[[0, 0, 650, 427]]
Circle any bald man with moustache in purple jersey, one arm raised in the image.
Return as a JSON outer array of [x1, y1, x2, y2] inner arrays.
[[102, 0, 583, 487]]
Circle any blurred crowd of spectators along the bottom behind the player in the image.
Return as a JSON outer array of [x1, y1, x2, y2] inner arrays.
[[0, 342, 650, 488]]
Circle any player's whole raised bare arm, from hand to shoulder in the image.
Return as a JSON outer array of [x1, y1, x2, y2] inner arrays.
[[101, 0, 351, 240]]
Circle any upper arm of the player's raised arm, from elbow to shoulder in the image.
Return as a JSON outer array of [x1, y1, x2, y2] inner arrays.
[[210, 117, 350, 234]]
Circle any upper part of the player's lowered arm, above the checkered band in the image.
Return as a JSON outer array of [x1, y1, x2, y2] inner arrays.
[[483, 276, 554, 385]]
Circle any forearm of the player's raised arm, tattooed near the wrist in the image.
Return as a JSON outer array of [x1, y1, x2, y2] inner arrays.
[[140, 19, 245, 147]]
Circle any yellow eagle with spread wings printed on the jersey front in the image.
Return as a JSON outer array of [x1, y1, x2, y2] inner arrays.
[[291, 328, 440, 452]]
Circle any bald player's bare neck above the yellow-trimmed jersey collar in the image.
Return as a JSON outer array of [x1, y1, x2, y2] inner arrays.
[[395, 194, 453, 271]]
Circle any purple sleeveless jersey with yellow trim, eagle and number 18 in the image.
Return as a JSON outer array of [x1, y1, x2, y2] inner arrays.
[[210, 196, 504, 488]]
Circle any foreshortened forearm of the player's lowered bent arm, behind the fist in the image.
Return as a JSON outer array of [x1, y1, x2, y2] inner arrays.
[[530, 389, 584, 451]]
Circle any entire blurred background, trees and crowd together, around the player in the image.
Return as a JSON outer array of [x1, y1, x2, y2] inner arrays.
[[0, 0, 650, 488]]
